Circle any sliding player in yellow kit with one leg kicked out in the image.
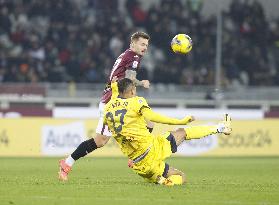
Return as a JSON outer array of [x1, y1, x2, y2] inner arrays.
[[104, 78, 232, 185]]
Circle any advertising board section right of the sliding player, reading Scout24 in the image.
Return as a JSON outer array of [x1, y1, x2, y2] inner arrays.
[[154, 119, 279, 156]]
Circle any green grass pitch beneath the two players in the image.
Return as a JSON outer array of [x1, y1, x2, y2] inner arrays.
[[0, 157, 279, 205]]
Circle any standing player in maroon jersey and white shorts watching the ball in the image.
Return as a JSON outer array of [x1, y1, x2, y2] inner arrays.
[[58, 32, 153, 181]]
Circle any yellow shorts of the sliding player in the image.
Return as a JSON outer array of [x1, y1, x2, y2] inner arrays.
[[133, 132, 177, 182]]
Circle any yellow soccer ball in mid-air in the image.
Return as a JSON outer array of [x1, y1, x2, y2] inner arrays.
[[171, 34, 193, 54]]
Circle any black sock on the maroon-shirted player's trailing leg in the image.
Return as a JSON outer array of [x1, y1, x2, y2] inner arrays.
[[71, 138, 98, 161]]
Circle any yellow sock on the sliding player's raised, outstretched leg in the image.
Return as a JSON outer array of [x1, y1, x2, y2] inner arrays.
[[185, 125, 217, 140]]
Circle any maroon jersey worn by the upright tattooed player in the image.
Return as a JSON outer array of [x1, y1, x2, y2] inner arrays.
[[101, 49, 141, 103]]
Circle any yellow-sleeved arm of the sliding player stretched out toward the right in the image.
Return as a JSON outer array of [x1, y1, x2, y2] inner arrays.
[[141, 108, 194, 125]]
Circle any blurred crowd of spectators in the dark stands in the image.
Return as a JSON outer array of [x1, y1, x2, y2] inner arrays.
[[0, 0, 279, 86]]
